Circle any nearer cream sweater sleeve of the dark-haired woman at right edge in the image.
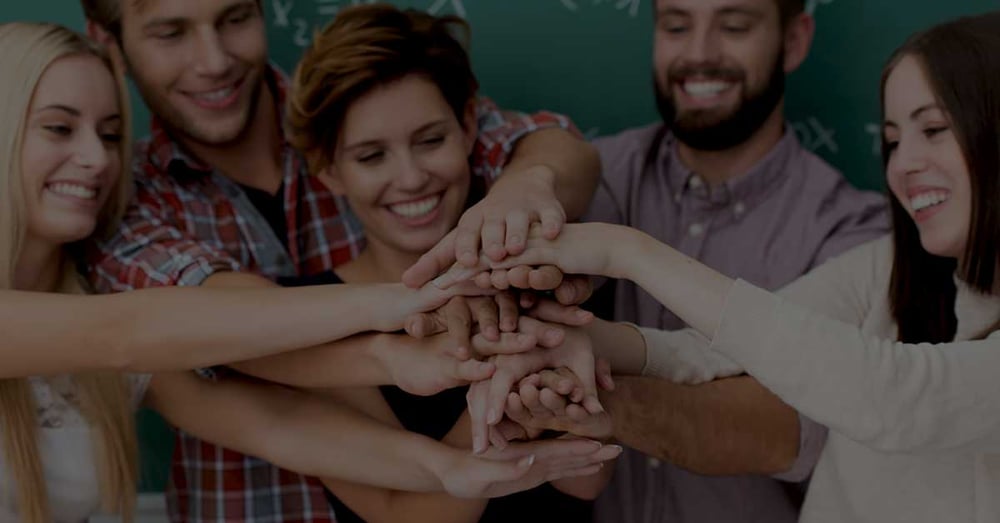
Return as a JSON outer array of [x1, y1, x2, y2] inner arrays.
[[712, 276, 1000, 453]]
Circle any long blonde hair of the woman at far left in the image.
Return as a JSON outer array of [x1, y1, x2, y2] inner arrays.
[[0, 22, 138, 523]]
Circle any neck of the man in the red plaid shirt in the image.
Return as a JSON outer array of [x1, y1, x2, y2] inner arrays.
[[181, 82, 282, 194]]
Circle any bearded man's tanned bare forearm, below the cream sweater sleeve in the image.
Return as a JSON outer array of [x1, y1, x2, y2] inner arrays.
[[601, 376, 799, 475]]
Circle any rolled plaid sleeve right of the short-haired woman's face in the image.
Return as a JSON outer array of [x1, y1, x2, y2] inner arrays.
[[472, 97, 582, 185]]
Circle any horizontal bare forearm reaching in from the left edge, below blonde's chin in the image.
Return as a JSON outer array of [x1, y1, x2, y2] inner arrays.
[[0, 280, 406, 377]]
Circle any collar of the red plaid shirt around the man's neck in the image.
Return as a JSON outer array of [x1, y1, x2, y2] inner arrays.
[[145, 64, 289, 175]]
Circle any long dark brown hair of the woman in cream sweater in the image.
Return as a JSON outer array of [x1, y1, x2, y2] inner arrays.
[[881, 13, 1000, 343]]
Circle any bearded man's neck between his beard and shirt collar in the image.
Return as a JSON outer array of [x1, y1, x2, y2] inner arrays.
[[678, 101, 785, 186]]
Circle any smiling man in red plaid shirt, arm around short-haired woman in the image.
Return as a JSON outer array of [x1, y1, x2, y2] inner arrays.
[[83, 0, 599, 522]]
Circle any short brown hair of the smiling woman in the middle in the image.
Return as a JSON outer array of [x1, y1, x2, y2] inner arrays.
[[286, 4, 479, 173]]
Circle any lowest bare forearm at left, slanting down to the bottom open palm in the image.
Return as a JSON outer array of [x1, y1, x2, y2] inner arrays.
[[147, 373, 457, 492]]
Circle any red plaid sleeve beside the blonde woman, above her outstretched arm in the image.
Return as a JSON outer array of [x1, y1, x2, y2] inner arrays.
[[89, 176, 241, 293]]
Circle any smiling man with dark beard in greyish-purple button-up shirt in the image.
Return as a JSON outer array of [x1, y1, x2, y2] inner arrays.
[[588, 0, 888, 523]]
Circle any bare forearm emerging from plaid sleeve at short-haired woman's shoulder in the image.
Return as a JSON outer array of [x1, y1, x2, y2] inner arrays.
[[497, 129, 601, 220]]
